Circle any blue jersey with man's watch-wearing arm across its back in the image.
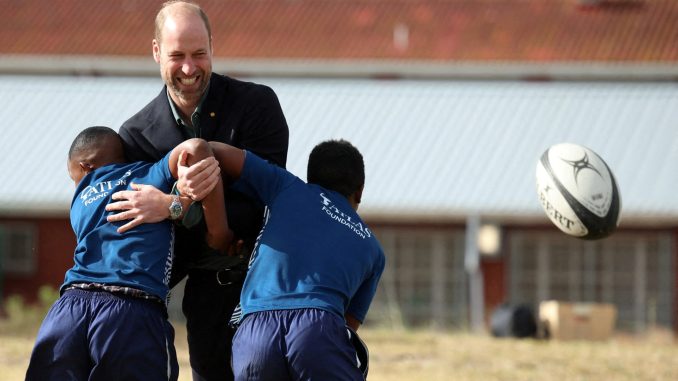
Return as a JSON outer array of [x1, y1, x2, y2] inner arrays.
[[61, 154, 174, 300]]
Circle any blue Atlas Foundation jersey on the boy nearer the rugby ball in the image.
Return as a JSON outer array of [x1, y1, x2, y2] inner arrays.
[[234, 152, 385, 321]]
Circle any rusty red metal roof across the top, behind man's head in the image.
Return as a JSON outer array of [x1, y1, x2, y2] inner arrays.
[[0, 0, 678, 63]]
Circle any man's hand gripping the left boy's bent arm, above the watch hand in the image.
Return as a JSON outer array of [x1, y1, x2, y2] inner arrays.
[[177, 152, 221, 201]]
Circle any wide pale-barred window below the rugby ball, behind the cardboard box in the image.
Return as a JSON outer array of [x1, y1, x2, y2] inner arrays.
[[508, 232, 674, 332]]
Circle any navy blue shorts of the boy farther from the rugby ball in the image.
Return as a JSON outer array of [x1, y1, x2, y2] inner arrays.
[[26, 290, 179, 381]]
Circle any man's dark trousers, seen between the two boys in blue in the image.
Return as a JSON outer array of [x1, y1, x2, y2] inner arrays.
[[182, 270, 244, 381]]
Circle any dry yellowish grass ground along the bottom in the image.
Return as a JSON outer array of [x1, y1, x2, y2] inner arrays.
[[0, 314, 678, 381]]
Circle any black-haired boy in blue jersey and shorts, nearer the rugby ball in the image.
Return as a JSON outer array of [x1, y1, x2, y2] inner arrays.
[[182, 140, 385, 381]]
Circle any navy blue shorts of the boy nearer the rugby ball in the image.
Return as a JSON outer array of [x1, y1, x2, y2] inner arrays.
[[232, 309, 364, 381]]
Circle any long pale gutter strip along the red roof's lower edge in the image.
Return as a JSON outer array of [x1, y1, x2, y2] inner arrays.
[[0, 54, 678, 82]]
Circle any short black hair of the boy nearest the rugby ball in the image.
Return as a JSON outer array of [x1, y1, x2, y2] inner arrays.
[[306, 139, 365, 198]]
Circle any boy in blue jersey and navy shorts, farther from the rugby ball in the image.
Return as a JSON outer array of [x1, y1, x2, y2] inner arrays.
[[26, 127, 231, 381]]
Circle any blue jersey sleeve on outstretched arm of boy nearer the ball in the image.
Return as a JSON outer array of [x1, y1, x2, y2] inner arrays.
[[232, 151, 295, 205]]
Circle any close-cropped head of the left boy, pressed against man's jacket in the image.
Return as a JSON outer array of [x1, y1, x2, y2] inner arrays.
[[68, 126, 125, 185]]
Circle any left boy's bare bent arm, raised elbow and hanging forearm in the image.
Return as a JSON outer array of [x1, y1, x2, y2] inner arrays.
[[169, 139, 233, 253]]
